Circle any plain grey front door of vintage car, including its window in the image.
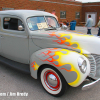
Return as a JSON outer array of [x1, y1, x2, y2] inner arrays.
[[1, 15, 29, 64]]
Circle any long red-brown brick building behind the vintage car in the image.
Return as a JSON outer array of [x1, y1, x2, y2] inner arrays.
[[0, 0, 100, 23]]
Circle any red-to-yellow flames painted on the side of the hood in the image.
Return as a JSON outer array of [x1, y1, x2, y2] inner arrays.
[[44, 32, 91, 53]]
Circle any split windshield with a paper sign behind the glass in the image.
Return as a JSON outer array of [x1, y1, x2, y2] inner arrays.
[[27, 16, 59, 31]]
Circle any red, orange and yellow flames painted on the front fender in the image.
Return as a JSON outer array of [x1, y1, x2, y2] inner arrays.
[[31, 48, 90, 86]]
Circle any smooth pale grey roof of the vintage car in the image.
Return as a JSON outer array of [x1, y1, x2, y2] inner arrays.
[[0, 10, 55, 18]]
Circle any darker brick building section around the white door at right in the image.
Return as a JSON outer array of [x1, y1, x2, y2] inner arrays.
[[82, 2, 100, 26]]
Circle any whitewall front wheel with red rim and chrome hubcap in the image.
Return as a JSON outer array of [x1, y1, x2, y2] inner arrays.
[[40, 67, 68, 97]]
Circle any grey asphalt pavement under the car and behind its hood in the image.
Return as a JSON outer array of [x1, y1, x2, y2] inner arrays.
[[0, 27, 100, 100]]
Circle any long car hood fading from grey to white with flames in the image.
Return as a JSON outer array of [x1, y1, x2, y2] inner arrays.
[[31, 30, 100, 54]]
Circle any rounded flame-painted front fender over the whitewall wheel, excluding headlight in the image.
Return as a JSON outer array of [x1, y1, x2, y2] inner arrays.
[[30, 48, 90, 87]]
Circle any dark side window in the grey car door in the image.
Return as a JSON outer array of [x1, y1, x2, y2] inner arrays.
[[3, 17, 24, 31]]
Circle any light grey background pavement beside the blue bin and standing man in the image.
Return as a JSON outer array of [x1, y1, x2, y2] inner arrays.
[[74, 26, 98, 35]]
